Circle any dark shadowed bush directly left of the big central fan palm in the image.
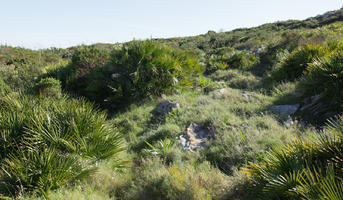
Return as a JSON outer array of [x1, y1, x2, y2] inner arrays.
[[43, 46, 112, 104]]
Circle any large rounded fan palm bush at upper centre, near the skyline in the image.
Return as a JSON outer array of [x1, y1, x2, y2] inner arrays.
[[111, 40, 202, 100]]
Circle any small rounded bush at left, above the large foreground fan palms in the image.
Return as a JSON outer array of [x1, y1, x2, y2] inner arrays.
[[35, 78, 62, 97]]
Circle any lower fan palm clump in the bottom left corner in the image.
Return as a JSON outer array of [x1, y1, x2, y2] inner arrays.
[[2, 147, 95, 192]]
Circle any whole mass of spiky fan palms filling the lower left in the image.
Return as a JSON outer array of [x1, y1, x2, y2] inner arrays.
[[0, 95, 122, 195]]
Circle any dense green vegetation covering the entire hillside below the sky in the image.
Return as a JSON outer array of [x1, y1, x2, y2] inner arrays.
[[0, 7, 343, 200]]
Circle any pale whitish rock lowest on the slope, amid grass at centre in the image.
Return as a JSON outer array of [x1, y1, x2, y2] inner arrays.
[[179, 123, 214, 152]]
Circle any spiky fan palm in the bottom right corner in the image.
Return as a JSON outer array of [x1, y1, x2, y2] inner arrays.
[[246, 117, 343, 199]]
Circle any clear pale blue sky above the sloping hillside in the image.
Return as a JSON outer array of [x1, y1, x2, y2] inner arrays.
[[0, 0, 343, 49]]
